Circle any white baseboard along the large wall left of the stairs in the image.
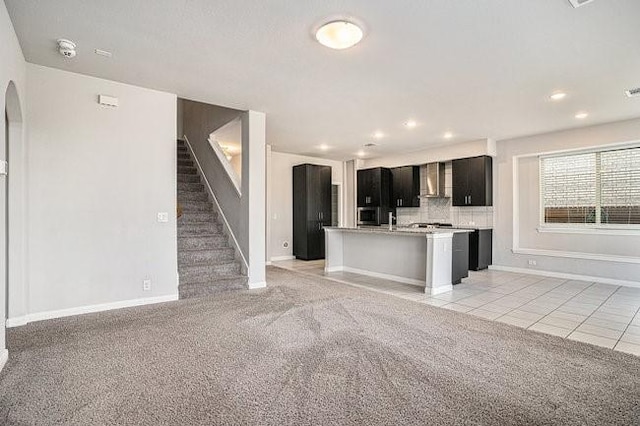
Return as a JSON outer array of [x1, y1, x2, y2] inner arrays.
[[7, 293, 178, 328]]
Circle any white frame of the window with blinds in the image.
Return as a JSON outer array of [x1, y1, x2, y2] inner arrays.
[[537, 142, 640, 231]]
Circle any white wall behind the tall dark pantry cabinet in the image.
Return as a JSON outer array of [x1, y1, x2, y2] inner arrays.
[[267, 151, 345, 260]]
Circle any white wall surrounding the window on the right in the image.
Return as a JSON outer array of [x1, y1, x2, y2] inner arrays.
[[493, 119, 640, 285]]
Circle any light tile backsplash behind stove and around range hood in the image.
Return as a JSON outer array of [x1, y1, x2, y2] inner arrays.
[[396, 161, 493, 227]]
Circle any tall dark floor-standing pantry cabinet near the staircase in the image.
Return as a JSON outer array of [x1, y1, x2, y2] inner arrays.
[[293, 164, 331, 260]]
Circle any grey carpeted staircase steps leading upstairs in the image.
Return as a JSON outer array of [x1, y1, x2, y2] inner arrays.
[[178, 141, 247, 299]]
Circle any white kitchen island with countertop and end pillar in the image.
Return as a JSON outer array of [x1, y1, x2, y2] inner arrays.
[[324, 227, 469, 295]]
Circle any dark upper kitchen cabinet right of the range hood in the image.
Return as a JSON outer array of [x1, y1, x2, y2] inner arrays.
[[451, 155, 493, 206]]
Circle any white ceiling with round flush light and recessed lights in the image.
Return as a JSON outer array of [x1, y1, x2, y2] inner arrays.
[[5, 0, 640, 159]]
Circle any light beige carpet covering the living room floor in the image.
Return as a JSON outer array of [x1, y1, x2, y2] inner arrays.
[[0, 268, 640, 425]]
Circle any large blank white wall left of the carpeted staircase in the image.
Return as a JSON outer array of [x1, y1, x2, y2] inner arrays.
[[27, 64, 177, 315]]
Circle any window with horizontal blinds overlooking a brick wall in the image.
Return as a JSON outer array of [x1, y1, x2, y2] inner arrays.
[[540, 147, 640, 226]]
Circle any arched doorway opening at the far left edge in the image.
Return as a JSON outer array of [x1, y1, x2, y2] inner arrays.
[[0, 82, 22, 319]]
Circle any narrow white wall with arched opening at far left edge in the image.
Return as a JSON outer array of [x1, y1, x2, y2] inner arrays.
[[0, 2, 26, 369]]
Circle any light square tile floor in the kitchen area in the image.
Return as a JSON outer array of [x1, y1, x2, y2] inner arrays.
[[273, 260, 640, 356]]
